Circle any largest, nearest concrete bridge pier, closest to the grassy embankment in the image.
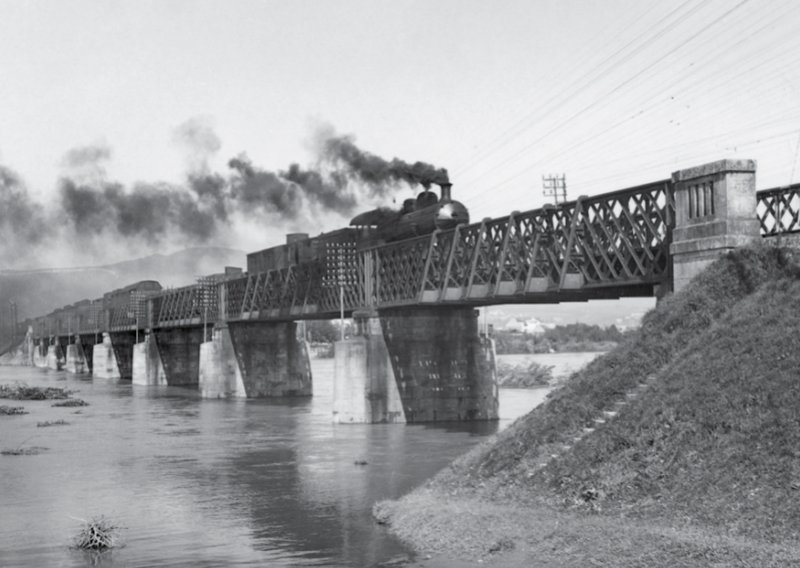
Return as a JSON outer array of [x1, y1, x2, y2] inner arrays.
[[333, 306, 498, 423]]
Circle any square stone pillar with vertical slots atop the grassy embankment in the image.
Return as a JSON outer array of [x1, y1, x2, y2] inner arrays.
[[670, 160, 761, 292]]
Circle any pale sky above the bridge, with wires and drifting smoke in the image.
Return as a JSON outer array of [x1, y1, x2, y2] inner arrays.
[[0, 0, 800, 267]]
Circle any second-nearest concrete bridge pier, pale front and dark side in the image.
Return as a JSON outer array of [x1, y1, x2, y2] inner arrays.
[[217, 321, 313, 398]]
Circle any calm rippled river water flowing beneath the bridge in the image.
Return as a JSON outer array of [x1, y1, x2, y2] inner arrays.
[[0, 354, 600, 568]]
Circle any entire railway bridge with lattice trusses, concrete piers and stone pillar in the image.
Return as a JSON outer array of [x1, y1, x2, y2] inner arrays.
[[9, 160, 800, 423]]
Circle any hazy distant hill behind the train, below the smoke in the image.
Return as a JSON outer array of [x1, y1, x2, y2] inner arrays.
[[0, 247, 246, 327]]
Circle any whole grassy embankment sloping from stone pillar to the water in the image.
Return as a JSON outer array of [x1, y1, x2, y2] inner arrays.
[[375, 248, 800, 567]]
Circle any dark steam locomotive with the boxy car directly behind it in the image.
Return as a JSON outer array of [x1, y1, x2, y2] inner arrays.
[[247, 183, 469, 273]]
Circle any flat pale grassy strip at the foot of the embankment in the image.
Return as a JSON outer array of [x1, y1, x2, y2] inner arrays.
[[380, 488, 800, 568]]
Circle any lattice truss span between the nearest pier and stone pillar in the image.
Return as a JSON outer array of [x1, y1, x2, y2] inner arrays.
[[360, 181, 675, 307]]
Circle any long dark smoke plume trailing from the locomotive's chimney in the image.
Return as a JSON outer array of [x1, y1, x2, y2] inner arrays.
[[0, 118, 447, 263]]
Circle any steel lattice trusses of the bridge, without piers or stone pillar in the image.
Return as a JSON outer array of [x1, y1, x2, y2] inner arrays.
[[25, 180, 800, 335]]
